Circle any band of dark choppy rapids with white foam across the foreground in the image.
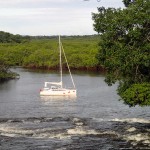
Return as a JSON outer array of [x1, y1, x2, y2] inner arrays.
[[0, 117, 150, 149]]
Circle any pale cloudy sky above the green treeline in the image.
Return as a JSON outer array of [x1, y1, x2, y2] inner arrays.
[[0, 0, 124, 36]]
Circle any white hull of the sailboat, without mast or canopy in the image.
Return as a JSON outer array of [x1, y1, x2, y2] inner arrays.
[[40, 89, 76, 96]]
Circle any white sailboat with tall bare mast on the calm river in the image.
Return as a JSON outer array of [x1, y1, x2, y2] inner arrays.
[[40, 36, 77, 96]]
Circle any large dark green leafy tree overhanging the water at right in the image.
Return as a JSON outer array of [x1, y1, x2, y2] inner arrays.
[[93, 0, 150, 106]]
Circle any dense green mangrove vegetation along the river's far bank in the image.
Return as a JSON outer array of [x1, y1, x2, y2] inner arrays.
[[0, 32, 100, 79]]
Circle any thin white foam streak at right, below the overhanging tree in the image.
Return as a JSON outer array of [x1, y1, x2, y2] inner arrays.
[[110, 118, 150, 123]]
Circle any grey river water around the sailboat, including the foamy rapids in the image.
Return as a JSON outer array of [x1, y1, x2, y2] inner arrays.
[[0, 68, 150, 150]]
